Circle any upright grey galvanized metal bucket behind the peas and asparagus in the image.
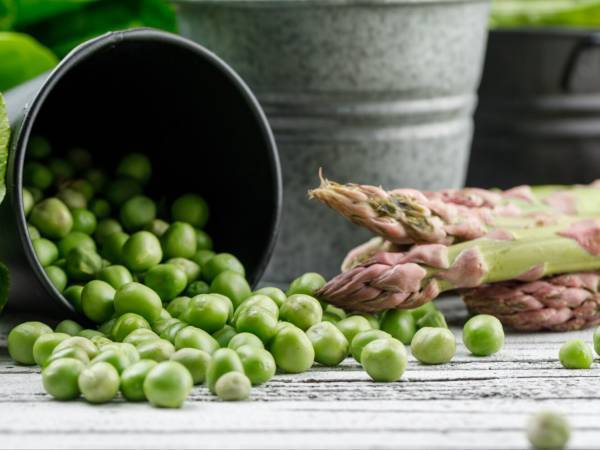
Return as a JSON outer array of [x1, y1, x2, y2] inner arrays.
[[175, 0, 489, 282]]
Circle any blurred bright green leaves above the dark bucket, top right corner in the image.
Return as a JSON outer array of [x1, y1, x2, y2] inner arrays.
[[490, 0, 600, 28]]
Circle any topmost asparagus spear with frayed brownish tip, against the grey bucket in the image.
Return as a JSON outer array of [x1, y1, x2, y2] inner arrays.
[[309, 176, 600, 244]]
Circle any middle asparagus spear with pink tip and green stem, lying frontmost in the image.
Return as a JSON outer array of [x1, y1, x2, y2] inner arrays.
[[317, 219, 600, 312]]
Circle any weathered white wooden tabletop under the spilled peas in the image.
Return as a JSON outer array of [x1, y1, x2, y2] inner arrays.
[[0, 299, 600, 449]]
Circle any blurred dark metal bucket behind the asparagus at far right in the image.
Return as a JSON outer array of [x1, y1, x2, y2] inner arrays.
[[467, 28, 600, 187]]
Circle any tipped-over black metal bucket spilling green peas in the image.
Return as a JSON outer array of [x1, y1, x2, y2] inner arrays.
[[0, 29, 281, 315]]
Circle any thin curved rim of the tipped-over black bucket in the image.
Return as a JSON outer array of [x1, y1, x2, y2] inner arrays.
[[11, 28, 283, 311]]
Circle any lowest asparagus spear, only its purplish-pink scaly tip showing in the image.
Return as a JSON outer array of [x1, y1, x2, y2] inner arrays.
[[463, 272, 600, 331]]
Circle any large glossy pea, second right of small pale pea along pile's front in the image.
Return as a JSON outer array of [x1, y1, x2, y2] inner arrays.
[[270, 325, 315, 373]]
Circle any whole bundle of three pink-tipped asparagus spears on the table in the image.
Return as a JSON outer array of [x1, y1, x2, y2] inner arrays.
[[310, 179, 600, 330]]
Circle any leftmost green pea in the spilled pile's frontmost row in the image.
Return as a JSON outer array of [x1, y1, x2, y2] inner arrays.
[[42, 358, 85, 400]]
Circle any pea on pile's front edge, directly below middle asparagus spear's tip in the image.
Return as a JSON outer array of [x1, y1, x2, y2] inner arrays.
[[308, 320, 356, 366]]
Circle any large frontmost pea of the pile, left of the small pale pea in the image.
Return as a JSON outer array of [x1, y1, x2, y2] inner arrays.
[[144, 361, 194, 408]]
